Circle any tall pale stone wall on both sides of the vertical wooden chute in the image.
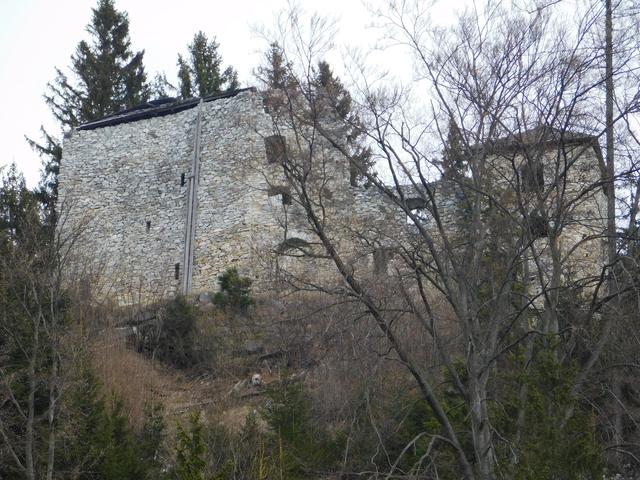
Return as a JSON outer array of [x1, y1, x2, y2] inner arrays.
[[60, 91, 380, 303]]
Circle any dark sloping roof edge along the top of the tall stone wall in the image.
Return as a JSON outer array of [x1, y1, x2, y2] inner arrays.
[[76, 87, 257, 130]]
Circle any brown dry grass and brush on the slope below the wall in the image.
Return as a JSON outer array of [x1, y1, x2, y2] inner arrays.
[[86, 286, 460, 435]]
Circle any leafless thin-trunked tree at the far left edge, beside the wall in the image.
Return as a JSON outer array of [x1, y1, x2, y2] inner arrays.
[[0, 170, 82, 480]]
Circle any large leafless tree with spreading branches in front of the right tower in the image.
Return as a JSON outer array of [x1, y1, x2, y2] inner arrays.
[[258, 2, 638, 479]]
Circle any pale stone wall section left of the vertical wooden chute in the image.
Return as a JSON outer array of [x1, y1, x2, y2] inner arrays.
[[59, 104, 196, 302]]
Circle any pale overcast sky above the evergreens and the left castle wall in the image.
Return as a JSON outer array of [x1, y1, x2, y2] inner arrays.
[[0, 0, 422, 186]]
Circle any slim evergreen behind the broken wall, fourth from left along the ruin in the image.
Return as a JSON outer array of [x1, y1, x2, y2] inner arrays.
[[314, 61, 373, 186]]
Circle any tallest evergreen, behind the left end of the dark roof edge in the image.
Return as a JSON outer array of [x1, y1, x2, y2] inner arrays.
[[27, 0, 150, 223]]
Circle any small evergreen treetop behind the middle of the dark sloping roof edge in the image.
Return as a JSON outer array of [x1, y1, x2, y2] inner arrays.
[[178, 31, 238, 98]]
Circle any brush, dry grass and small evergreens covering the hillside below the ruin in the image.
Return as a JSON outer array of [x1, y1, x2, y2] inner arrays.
[[0, 168, 628, 479]]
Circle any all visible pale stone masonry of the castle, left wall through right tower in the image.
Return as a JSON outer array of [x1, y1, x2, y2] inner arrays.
[[59, 91, 605, 303]]
